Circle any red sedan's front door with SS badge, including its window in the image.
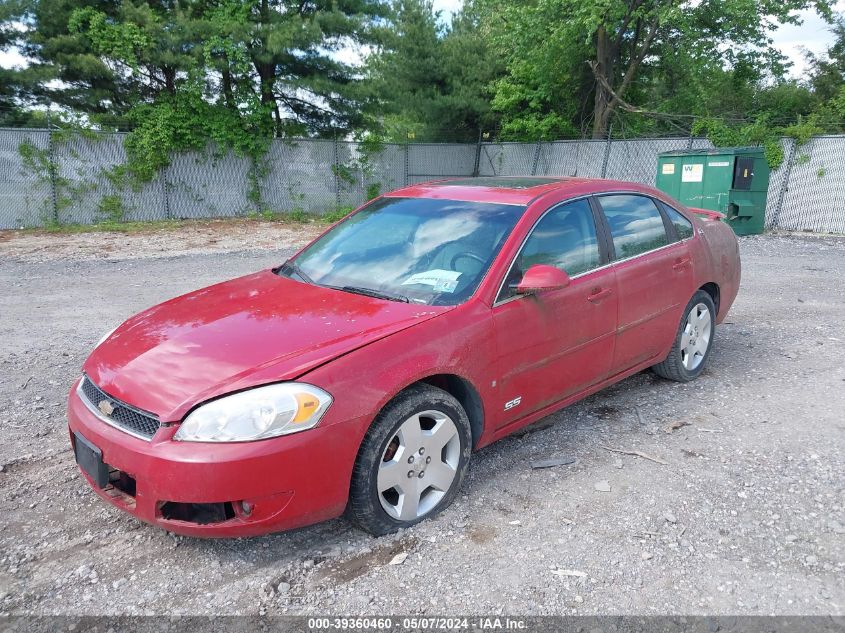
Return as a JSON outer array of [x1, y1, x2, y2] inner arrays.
[[493, 199, 618, 426]]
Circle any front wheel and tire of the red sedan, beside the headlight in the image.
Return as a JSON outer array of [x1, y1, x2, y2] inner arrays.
[[347, 384, 472, 536]]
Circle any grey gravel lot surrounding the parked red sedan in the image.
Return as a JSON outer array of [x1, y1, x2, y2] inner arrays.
[[0, 230, 845, 615]]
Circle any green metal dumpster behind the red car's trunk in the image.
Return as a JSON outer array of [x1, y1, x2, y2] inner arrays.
[[657, 147, 769, 235]]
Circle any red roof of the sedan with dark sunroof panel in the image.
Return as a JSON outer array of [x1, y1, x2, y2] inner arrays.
[[385, 176, 657, 205]]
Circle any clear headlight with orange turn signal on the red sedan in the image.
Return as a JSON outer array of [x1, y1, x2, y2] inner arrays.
[[173, 382, 332, 442]]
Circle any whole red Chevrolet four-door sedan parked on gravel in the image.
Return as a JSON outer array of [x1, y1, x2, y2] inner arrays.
[[68, 178, 740, 536]]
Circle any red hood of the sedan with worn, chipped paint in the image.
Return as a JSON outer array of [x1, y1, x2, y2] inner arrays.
[[83, 270, 451, 421]]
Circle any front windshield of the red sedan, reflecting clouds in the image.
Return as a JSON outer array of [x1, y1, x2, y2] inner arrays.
[[279, 198, 525, 305]]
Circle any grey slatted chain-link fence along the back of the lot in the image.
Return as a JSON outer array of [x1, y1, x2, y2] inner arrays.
[[0, 129, 845, 233]]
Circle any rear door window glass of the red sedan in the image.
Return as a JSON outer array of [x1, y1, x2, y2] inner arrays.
[[597, 194, 669, 259]]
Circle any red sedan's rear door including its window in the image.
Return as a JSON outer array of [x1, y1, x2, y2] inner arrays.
[[595, 193, 694, 374]]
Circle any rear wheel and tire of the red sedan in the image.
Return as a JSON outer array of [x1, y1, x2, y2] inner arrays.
[[652, 290, 716, 382]]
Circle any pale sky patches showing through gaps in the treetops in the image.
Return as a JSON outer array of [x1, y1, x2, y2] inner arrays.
[[0, 0, 845, 78]]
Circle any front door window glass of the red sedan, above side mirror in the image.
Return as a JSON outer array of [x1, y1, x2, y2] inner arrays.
[[498, 200, 601, 301]]
